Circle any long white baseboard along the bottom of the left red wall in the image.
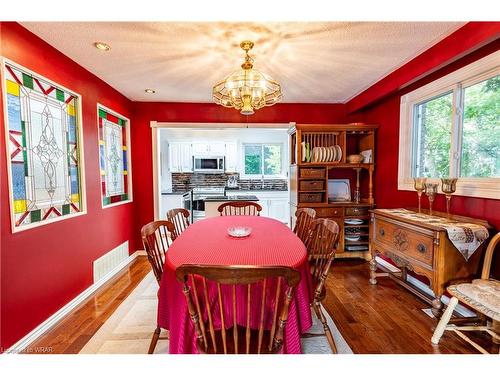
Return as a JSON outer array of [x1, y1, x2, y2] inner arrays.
[[4, 250, 146, 354]]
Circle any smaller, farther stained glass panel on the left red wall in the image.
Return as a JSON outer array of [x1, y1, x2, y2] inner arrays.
[[97, 107, 131, 206]]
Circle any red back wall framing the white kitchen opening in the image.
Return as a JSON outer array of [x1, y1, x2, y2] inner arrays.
[[131, 102, 345, 248]]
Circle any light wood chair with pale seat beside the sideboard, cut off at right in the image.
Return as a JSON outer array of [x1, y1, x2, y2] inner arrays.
[[431, 233, 500, 354]]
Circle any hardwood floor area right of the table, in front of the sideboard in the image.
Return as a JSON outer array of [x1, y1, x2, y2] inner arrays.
[[323, 259, 498, 354]]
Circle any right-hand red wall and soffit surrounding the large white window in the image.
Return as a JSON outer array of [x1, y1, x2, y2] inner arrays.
[[347, 22, 500, 230]]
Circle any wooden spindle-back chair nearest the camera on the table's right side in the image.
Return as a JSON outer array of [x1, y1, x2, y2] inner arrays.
[[306, 219, 339, 353]]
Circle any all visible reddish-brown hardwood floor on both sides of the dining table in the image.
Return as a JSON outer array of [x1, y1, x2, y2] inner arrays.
[[26, 256, 498, 354]]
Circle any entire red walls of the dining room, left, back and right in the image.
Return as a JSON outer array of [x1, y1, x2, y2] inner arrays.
[[0, 22, 500, 348]]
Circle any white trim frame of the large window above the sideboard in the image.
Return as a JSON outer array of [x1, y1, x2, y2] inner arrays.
[[398, 51, 500, 203]]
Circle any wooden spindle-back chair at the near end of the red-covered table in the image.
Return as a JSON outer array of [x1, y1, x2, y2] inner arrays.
[[176, 264, 300, 354]]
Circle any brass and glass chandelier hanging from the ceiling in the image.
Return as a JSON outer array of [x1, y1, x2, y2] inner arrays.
[[212, 40, 282, 115]]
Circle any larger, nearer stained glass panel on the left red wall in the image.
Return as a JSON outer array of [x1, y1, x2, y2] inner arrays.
[[4, 62, 84, 231]]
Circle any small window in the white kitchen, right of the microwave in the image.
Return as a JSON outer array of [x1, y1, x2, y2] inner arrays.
[[243, 143, 283, 178]]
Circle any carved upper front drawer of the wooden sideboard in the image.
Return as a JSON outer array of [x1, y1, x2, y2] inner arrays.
[[373, 218, 434, 266]]
